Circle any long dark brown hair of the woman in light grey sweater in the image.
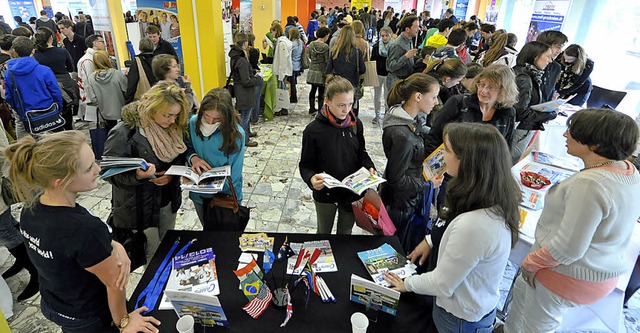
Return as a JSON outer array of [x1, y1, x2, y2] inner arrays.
[[442, 123, 522, 247]]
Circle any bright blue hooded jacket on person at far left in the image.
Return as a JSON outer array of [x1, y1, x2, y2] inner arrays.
[[4, 57, 62, 116]]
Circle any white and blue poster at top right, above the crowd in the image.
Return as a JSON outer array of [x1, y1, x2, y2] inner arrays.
[[526, 0, 571, 43]]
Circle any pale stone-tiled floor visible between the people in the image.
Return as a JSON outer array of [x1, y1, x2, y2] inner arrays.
[[0, 79, 640, 333]]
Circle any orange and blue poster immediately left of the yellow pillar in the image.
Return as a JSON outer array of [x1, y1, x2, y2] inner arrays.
[[136, 0, 184, 66]]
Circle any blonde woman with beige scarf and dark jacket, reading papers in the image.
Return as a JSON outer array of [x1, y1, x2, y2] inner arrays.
[[104, 82, 190, 262]]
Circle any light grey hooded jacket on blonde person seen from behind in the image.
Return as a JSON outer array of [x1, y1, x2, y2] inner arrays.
[[87, 68, 127, 120]]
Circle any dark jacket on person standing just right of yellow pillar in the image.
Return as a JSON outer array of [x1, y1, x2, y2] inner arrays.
[[229, 45, 262, 110]]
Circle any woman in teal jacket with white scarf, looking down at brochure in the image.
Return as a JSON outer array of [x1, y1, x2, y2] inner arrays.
[[187, 88, 246, 224]]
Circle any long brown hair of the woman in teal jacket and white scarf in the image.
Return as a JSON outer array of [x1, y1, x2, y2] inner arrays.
[[195, 88, 241, 156]]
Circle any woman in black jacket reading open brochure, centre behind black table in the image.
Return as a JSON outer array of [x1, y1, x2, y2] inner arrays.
[[298, 75, 377, 234]]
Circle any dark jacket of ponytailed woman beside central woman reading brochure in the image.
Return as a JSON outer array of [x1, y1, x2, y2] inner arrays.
[[380, 105, 427, 210]]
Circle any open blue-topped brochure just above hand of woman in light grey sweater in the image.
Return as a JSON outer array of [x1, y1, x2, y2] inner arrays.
[[358, 243, 416, 287]]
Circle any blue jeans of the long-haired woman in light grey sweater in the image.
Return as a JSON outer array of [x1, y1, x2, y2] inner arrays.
[[433, 304, 498, 333]]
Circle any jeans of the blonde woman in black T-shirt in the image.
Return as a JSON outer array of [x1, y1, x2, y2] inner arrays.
[[40, 300, 118, 333]]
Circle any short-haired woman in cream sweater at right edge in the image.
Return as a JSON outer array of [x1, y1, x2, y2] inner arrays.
[[504, 109, 640, 333]]
